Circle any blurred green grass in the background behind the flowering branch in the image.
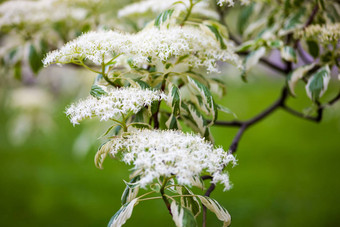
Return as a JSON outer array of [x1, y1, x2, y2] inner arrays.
[[0, 72, 340, 227]]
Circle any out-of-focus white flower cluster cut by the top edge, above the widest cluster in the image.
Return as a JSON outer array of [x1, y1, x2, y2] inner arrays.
[[118, 0, 219, 20]]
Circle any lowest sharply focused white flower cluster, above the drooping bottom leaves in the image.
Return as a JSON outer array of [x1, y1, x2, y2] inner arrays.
[[110, 129, 236, 189]]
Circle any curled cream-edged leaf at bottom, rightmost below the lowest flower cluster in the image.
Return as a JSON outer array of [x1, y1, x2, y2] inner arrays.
[[197, 195, 231, 227]]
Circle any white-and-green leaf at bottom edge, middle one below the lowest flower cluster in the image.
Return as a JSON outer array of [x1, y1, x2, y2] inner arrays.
[[170, 201, 197, 227]]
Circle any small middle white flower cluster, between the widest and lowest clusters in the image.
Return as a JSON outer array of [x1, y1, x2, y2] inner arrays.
[[66, 87, 167, 125]]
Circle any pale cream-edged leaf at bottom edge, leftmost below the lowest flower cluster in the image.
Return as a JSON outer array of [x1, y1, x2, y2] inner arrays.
[[107, 199, 138, 227]]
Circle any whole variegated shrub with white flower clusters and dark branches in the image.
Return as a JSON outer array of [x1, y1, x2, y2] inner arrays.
[[0, 0, 340, 227]]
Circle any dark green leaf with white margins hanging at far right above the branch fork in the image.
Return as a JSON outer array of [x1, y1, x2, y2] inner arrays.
[[306, 65, 331, 101]]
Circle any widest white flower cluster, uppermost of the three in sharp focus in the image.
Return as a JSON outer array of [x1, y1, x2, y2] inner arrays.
[[43, 26, 242, 72]]
